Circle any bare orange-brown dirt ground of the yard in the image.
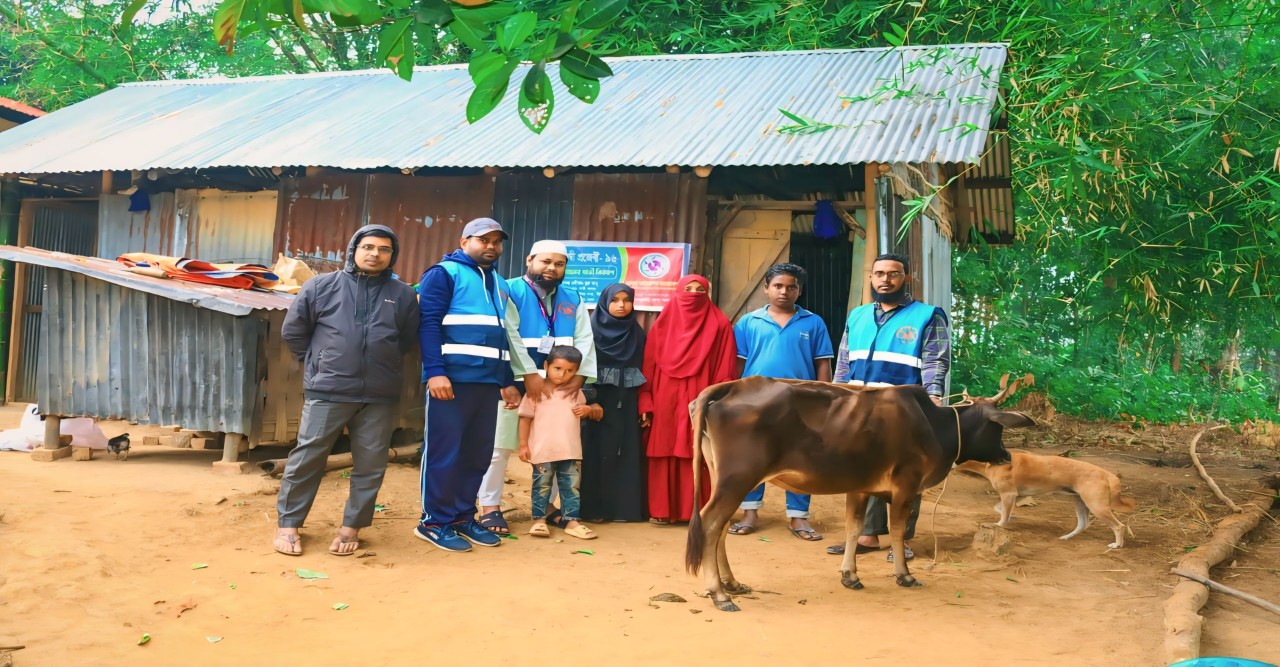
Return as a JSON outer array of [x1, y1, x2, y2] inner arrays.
[[0, 408, 1280, 667]]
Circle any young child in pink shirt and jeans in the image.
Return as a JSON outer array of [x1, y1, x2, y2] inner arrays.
[[520, 346, 604, 540]]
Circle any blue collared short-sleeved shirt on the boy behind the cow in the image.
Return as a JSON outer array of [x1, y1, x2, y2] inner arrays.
[[733, 306, 835, 380]]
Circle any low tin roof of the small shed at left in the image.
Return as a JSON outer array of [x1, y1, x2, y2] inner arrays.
[[0, 246, 293, 316]]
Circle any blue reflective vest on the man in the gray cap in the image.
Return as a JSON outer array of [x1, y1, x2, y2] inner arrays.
[[440, 261, 511, 384]]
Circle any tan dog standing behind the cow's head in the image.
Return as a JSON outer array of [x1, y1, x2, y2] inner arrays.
[[956, 452, 1134, 549]]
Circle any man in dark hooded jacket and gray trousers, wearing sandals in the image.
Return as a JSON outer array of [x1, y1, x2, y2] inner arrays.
[[273, 224, 419, 556]]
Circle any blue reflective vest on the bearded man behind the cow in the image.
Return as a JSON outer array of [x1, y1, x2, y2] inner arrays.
[[846, 301, 945, 387]]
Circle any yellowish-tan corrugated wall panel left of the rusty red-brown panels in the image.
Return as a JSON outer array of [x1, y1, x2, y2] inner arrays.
[[177, 189, 276, 266]]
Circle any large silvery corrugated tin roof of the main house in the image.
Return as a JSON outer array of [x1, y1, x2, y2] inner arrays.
[[0, 44, 1006, 174]]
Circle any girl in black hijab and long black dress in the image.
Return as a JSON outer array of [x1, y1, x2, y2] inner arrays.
[[581, 283, 648, 521]]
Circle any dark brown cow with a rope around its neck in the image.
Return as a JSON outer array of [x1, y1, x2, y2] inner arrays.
[[685, 378, 1036, 612]]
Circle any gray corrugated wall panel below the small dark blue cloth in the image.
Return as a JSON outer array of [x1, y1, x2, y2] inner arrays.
[[96, 192, 187, 260]]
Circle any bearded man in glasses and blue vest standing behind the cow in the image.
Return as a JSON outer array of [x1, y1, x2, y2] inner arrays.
[[827, 253, 951, 562]]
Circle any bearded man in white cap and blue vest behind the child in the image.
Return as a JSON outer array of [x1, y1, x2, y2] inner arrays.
[[477, 241, 595, 535]]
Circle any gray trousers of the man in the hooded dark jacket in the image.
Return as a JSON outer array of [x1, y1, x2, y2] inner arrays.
[[275, 398, 399, 529]]
